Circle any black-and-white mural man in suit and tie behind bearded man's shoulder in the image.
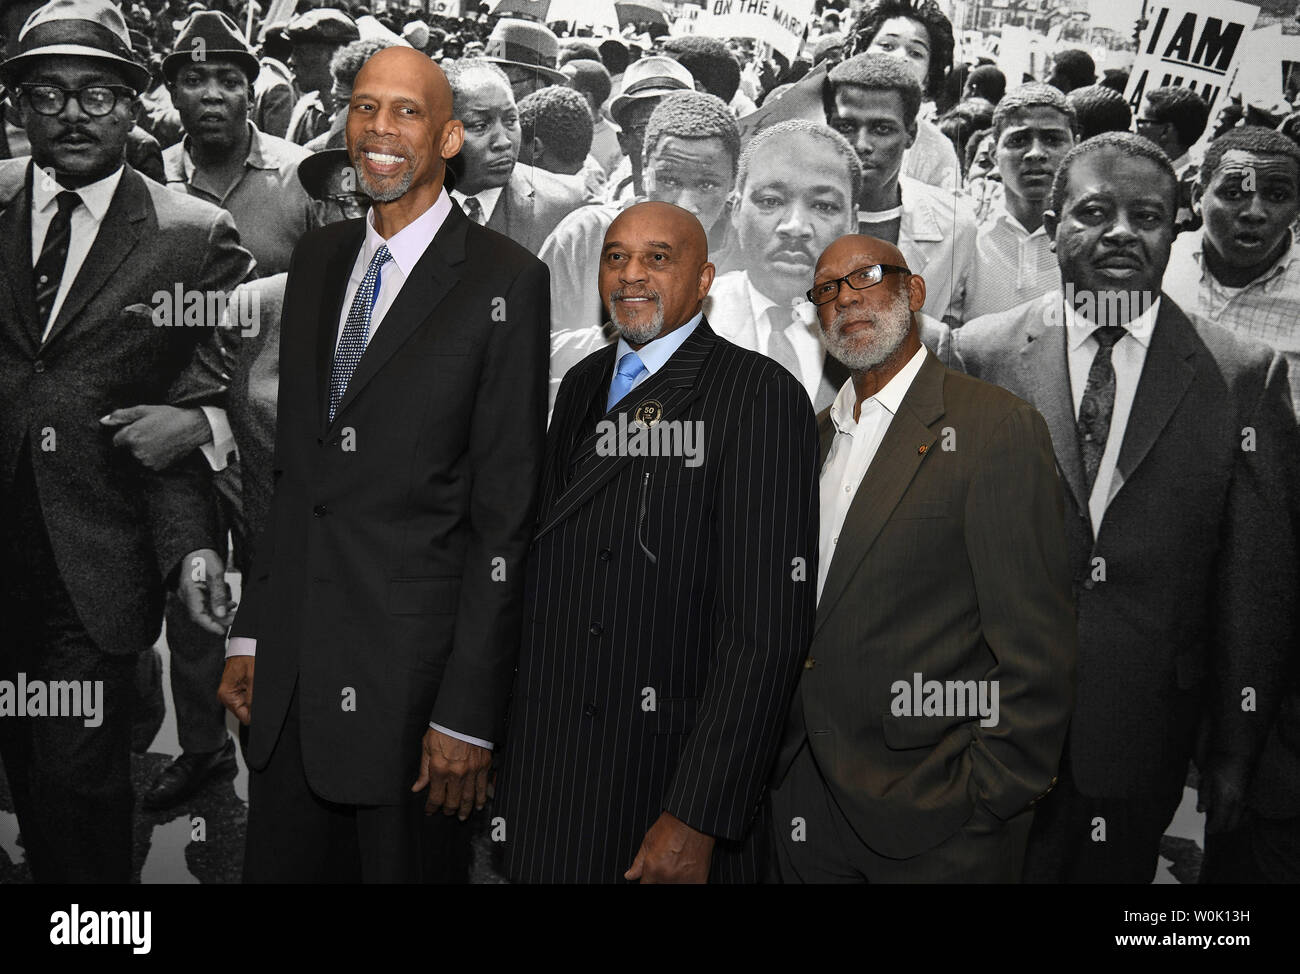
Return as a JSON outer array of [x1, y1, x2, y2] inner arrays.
[[954, 133, 1300, 883]]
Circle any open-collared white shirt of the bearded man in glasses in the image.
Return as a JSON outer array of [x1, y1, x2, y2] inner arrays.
[[816, 346, 926, 602]]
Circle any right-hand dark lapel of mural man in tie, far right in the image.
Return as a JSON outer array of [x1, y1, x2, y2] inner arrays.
[[1110, 298, 1196, 486]]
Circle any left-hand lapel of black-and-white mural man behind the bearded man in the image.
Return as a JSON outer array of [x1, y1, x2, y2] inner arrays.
[[1019, 291, 1088, 511]]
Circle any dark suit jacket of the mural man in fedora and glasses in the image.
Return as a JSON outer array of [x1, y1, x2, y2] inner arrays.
[[0, 157, 254, 653]]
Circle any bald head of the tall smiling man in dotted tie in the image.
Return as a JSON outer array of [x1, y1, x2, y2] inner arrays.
[[346, 47, 464, 210]]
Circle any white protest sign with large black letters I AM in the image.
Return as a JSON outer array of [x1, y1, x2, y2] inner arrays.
[[1125, 0, 1260, 117]]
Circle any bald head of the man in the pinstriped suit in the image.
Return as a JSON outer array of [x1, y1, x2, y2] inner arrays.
[[599, 202, 714, 349]]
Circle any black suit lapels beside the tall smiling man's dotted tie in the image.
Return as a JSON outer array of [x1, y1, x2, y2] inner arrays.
[[324, 207, 469, 423]]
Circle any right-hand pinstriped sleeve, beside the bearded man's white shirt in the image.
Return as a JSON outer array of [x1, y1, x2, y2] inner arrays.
[[663, 372, 819, 840]]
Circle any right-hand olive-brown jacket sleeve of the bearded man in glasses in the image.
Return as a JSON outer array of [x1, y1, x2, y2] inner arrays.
[[966, 403, 1078, 819]]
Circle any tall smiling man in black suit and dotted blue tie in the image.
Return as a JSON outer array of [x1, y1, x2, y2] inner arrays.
[[221, 47, 550, 882]]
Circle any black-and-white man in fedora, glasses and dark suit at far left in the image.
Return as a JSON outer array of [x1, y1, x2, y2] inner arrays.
[[0, 0, 254, 883]]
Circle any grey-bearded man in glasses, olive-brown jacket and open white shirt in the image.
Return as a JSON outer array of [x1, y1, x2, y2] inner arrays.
[[771, 235, 1075, 883]]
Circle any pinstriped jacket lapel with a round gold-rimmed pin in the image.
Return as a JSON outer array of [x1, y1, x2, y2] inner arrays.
[[537, 319, 718, 537]]
